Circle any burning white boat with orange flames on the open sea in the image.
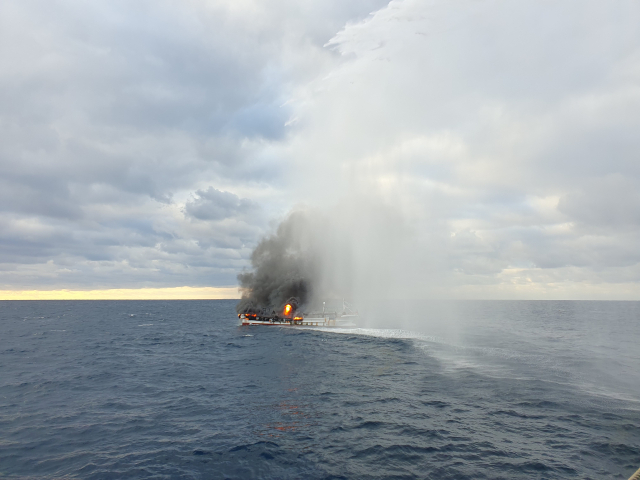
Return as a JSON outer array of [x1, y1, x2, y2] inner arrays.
[[238, 298, 358, 327]]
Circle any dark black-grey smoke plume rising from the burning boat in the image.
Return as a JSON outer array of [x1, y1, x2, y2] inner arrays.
[[236, 211, 320, 313]]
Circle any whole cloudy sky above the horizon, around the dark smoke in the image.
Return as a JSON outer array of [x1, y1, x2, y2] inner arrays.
[[0, 0, 640, 300]]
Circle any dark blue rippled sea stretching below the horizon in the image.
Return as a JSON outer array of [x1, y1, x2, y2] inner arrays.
[[0, 301, 640, 479]]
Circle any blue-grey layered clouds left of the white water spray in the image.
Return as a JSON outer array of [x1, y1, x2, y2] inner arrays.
[[0, 0, 384, 289]]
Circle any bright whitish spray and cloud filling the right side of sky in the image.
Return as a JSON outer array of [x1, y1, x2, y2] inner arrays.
[[278, 0, 640, 296]]
